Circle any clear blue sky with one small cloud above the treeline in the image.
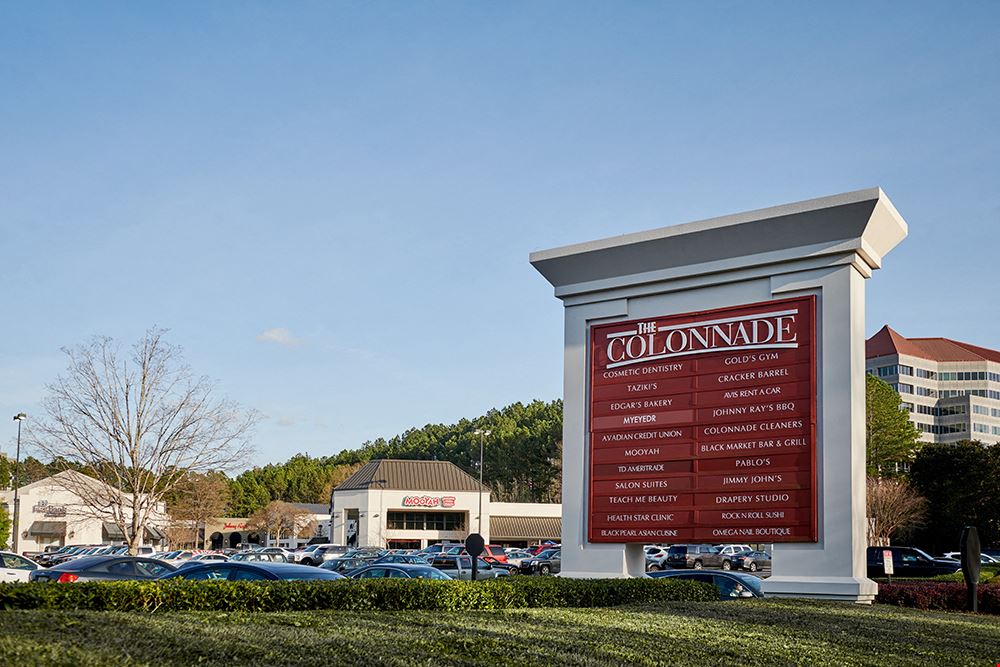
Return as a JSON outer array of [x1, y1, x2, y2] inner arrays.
[[0, 2, 1000, 463]]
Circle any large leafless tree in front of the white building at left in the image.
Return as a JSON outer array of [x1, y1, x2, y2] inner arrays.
[[29, 329, 256, 553]]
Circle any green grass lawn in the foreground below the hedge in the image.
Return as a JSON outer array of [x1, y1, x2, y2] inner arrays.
[[0, 600, 1000, 667]]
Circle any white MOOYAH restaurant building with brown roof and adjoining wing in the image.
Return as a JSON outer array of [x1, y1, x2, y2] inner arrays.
[[330, 459, 562, 549]]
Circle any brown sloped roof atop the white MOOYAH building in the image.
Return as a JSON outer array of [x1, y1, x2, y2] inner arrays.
[[334, 459, 489, 491]]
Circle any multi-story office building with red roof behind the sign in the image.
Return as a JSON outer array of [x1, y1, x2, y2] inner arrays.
[[865, 326, 1000, 444]]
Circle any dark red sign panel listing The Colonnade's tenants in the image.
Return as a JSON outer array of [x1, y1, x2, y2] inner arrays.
[[589, 296, 817, 543]]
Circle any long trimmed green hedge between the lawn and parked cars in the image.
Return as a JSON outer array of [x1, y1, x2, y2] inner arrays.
[[0, 577, 719, 612]]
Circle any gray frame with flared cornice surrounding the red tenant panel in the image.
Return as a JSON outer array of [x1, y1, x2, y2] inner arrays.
[[530, 188, 908, 602]]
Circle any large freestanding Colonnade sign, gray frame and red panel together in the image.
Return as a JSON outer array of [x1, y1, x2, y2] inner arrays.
[[531, 188, 907, 602]]
